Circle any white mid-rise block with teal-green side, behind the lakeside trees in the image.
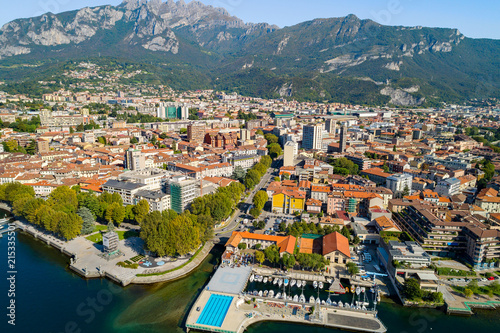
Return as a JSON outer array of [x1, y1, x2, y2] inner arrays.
[[169, 176, 200, 214]]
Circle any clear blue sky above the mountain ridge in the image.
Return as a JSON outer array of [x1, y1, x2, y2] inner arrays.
[[0, 0, 500, 39]]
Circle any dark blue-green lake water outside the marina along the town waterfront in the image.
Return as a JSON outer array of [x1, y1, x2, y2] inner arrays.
[[0, 233, 500, 333]]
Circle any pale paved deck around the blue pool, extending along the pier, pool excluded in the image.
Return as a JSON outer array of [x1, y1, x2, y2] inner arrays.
[[186, 290, 387, 333]]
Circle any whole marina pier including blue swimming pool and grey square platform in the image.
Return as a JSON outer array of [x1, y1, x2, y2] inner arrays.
[[186, 267, 387, 333]]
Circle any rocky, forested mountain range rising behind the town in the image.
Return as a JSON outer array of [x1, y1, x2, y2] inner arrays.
[[0, 0, 500, 106]]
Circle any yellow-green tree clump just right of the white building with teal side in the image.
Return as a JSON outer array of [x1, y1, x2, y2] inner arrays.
[[190, 182, 245, 222]]
